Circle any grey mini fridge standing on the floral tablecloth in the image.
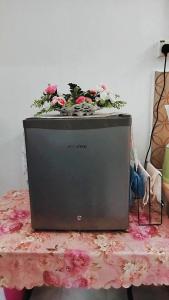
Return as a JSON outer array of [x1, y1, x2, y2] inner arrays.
[[23, 114, 131, 230]]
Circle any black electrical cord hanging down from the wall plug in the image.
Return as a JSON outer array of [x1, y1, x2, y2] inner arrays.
[[144, 52, 168, 169]]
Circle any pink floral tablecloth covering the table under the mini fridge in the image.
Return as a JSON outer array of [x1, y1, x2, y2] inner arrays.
[[0, 191, 169, 289]]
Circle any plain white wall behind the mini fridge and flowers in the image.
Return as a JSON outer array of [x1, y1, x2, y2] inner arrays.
[[0, 0, 169, 194]]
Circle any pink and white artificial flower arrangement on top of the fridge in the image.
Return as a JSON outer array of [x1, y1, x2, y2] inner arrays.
[[32, 83, 125, 115]]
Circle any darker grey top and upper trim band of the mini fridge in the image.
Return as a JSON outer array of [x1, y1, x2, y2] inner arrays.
[[23, 114, 131, 130]]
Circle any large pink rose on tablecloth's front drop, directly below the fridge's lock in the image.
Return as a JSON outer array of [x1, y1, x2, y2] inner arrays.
[[64, 250, 90, 274]]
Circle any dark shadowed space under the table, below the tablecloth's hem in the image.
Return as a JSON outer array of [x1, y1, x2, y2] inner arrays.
[[30, 286, 169, 300]]
